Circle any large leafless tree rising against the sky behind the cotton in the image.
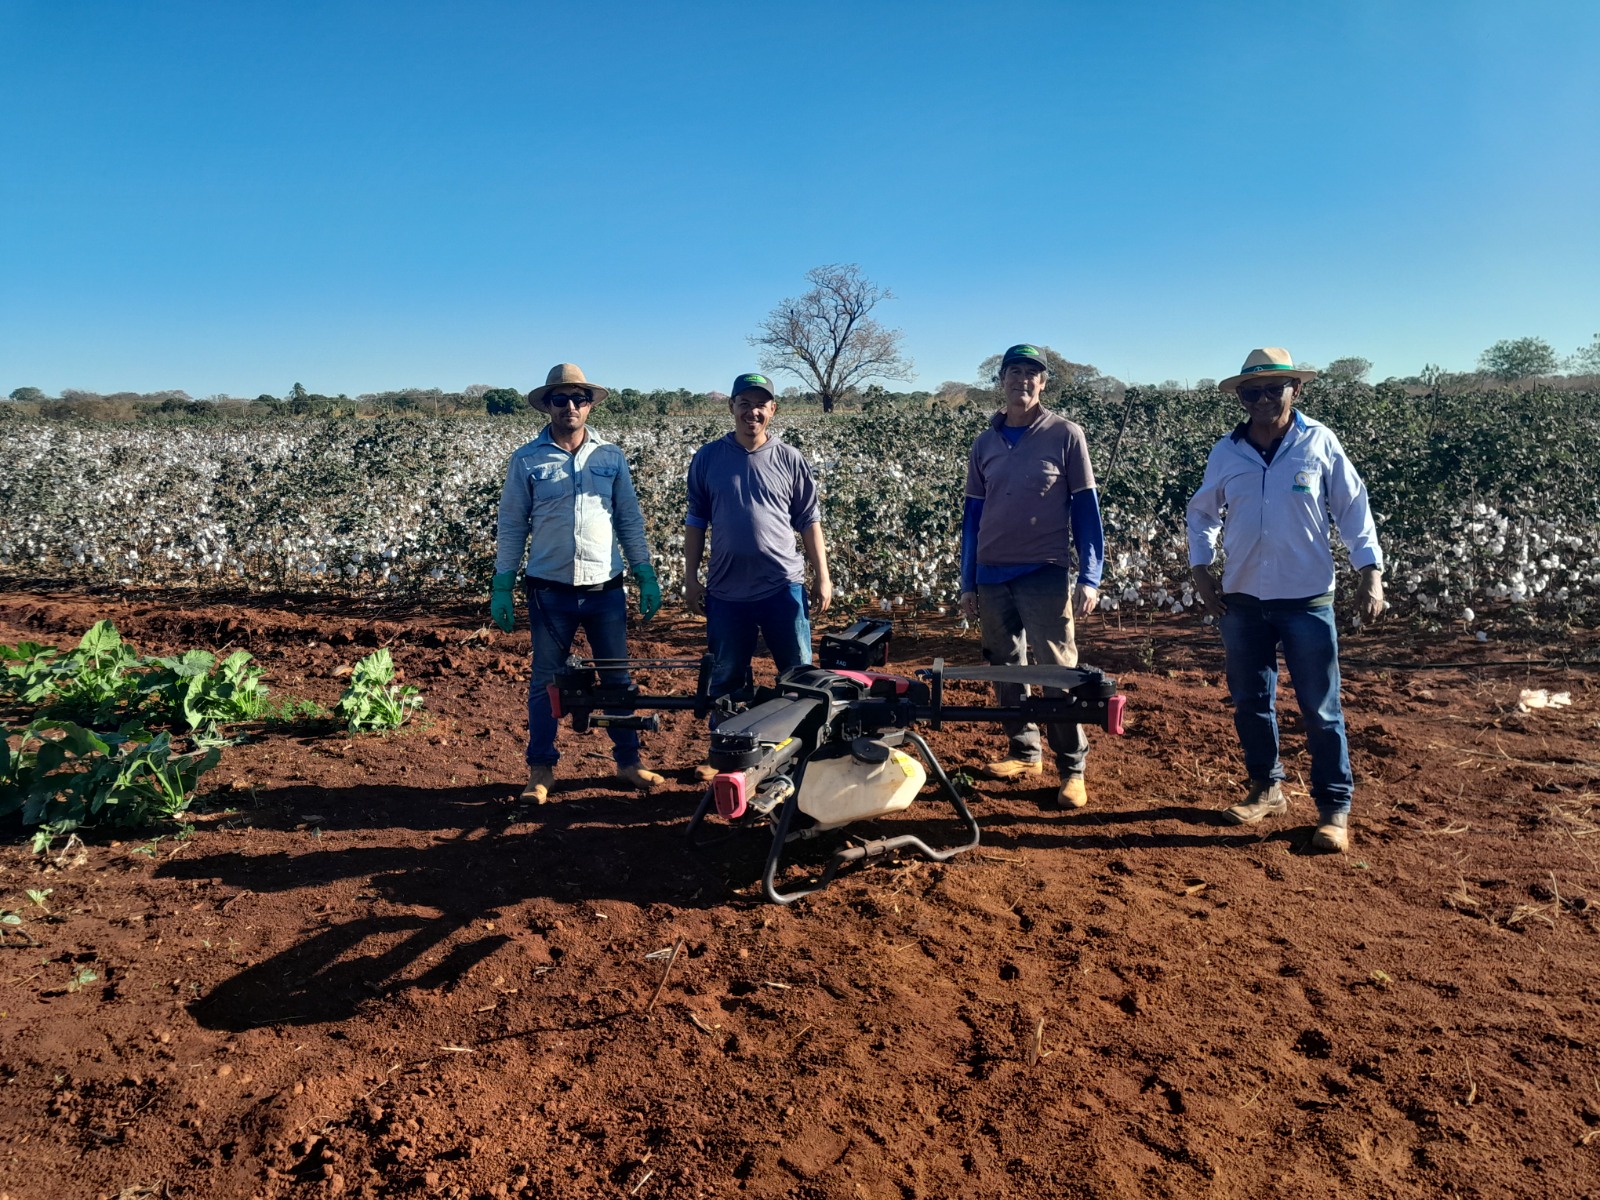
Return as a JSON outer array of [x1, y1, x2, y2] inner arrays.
[[749, 262, 912, 413]]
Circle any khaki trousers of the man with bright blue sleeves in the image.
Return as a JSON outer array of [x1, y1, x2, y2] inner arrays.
[[978, 566, 1090, 779]]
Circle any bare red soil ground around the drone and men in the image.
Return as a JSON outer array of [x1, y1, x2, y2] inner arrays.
[[0, 592, 1600, 1200]]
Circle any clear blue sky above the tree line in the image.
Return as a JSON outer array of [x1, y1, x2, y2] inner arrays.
[[0, 0, 1600, 395]]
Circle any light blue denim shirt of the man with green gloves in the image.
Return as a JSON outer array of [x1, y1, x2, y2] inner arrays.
[[494, 426, 650, 587]]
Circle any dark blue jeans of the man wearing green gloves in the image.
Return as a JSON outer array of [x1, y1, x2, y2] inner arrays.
[[526, 586, 638, 766]]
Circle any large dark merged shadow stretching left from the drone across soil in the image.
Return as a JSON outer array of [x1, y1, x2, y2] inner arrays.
[[168, 787, 979, 1030]]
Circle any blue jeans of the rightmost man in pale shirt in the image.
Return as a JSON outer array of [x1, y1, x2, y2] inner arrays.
[[1222, 595, 1355, 816]]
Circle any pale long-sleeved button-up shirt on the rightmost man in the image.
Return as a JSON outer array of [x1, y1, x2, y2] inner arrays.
[[1189, 411, 1384, 600]]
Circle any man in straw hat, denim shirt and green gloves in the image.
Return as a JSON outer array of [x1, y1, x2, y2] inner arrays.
[[490, 363, 662, 805]]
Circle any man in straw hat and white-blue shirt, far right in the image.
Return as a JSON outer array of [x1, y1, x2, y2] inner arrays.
[[1189, 346, 1384, 851]]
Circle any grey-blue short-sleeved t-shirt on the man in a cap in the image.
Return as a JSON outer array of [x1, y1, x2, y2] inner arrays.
[[685, 434, 821, 600]]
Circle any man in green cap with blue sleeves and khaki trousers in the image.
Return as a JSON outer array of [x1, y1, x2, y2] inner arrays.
[[962, 344, 1106, 808]]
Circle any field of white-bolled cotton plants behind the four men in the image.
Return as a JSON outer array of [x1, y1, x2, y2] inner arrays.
[[0, 389, 1600, 626]]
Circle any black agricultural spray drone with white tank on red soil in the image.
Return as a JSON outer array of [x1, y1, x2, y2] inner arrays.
[[550, 621, 1123, 904]]
